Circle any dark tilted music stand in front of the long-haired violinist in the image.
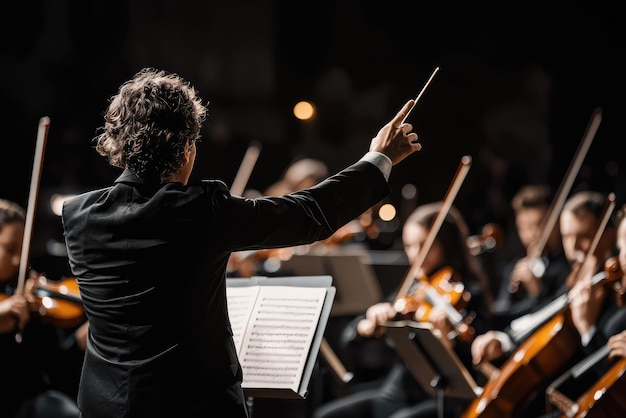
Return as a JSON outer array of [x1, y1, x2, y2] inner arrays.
[[385, 321, 482, 417]]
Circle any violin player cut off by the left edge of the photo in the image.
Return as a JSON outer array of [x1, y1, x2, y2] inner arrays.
[[0, 199, 85, 418]]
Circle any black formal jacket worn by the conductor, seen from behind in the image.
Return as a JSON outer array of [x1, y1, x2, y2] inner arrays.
[[62, 161, 390, 418]]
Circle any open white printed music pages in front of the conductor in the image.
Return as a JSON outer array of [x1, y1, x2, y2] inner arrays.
[[227, 286, 326, 392]]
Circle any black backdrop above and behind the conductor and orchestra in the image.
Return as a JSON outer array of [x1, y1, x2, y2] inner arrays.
[[0, 0, 626, 278]]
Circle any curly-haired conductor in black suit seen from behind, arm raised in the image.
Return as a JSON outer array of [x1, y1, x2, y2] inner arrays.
[[62, 68, 421, 418]]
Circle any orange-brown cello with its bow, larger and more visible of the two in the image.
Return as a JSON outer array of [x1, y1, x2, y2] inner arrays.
[[461, 194, 616, 418]]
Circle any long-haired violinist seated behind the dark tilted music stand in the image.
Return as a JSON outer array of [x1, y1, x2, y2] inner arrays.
[[313, 202, 489, 418]]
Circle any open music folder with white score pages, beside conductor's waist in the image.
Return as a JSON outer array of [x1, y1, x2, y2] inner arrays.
[[226, 276, 335, 399]]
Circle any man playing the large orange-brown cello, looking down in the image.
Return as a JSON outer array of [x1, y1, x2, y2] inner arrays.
[[471, 191, 615, 416]]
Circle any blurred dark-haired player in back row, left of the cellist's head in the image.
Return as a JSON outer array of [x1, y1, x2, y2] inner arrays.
[[493, 184, 570, 328]]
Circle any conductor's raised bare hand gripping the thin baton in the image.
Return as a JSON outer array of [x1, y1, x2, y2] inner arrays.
[[370, 99, 422, 165]]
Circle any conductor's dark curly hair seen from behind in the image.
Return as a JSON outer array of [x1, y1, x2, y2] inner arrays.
[[94, 68, 207, 182]]
